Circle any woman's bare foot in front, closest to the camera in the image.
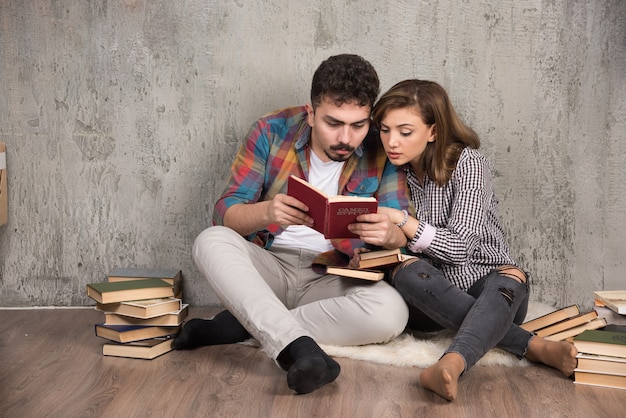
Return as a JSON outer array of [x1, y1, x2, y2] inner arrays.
[[420, 353, 465, 401]]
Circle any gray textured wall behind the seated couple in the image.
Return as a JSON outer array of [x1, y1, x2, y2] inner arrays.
[[0, 0, 626, 306]]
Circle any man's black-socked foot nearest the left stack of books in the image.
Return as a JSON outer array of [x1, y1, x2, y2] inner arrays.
[[172, 311, 251, 350]]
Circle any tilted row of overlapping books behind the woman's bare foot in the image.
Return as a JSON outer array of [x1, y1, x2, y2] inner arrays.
[[520, 305, 607, 341]]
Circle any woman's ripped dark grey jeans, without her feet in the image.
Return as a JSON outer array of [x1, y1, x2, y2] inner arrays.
[[392, 260, 533, 371]]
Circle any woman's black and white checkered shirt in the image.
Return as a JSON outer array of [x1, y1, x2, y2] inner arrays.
[[406, 147, 517, 290]]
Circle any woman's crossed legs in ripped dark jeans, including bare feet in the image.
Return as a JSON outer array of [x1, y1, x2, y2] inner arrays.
[[394, 260, 576, 400]]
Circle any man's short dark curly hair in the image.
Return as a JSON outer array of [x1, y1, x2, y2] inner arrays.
[[311, 54, 380, 109]]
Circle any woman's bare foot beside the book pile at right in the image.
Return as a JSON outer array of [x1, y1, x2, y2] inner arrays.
[[526, 336, 578, 376]]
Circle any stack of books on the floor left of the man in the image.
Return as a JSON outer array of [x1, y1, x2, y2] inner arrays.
[[87, 268, 189, 359]]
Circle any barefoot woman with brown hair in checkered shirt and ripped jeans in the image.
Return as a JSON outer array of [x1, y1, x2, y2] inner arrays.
[[357, 80, 576, 400]]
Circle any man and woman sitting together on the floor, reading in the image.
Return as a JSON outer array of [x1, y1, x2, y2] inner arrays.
[[174, 54, 576, 400]]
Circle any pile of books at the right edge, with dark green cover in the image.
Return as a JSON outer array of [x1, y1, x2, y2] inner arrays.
[[573, 290, 626, 389]]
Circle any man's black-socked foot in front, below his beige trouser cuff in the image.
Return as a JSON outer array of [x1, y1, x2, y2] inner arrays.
[[277, 337, 341, 393]]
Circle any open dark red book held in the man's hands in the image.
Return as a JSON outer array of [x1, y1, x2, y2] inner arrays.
[[287, 175, 378, 239]]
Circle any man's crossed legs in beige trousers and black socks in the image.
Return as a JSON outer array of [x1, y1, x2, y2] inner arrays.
[[174, 227, 408, 393]]
